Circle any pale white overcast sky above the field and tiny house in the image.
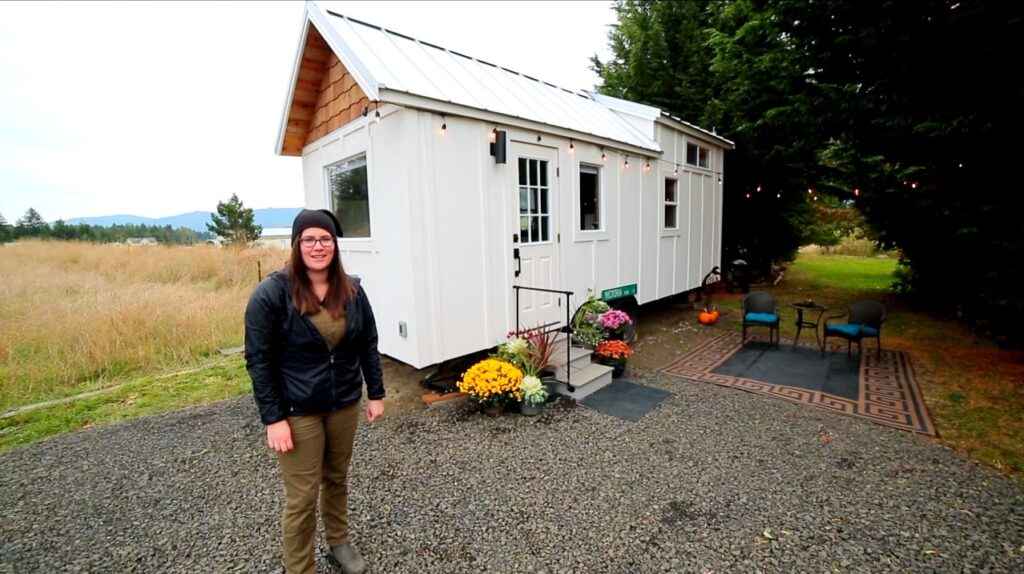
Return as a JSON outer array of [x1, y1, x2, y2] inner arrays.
[[0, 0, 615, 224]]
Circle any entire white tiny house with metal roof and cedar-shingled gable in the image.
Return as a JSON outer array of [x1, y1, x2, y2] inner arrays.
[[276, 2, 732, 368]]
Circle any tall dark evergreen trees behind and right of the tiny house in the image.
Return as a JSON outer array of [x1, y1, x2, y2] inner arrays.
[[593, 0, 1024, 347]]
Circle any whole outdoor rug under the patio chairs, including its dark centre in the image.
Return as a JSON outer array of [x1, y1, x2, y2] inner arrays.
[[655, 333, 935, 436]]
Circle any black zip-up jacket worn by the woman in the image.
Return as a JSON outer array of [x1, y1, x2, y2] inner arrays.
[[246, 270, 384, 425]]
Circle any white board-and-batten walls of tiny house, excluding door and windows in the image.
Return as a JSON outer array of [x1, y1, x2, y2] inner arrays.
[[303, 105, 722, 367]]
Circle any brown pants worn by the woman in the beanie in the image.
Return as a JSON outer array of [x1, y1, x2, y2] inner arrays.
[[278, 403, 359, 574]]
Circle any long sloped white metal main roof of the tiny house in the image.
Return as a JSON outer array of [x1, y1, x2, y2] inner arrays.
[[307, 2, 662, 152]]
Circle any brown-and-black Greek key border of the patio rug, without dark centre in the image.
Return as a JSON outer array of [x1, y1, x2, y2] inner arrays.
[[658, 333, 936, 436]]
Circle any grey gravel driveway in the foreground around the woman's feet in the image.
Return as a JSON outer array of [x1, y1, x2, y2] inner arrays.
[[0, 371, 1024, 573]]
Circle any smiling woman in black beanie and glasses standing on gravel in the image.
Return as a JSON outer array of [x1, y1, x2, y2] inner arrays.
[[246, 210, 384, 574]]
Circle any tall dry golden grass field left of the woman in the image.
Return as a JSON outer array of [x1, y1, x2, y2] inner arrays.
[[0, 241, 288, 411]]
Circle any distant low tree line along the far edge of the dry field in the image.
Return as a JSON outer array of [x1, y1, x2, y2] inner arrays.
[[0, 208, 213, 246]]
